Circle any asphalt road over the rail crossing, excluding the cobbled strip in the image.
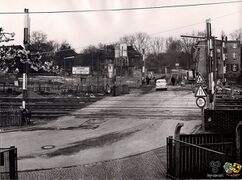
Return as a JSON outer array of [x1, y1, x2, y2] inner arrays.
[[0, 87, 201, 170]]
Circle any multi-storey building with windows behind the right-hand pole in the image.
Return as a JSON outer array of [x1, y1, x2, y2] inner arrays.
[[193, 40, 242, 79]]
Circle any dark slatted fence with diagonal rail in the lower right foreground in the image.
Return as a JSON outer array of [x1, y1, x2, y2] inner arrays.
[[167, 134, 235, 178]]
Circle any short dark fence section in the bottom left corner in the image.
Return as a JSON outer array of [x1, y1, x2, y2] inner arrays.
[[0, 146, 18, 180]]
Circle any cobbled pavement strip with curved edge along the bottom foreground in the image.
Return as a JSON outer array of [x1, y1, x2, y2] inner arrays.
[[18, 147, 169, 180]]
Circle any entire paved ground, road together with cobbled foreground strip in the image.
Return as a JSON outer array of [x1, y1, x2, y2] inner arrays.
[[0, 87, 201, 179]]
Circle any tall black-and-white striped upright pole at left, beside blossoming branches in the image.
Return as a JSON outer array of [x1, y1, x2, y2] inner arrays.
[[22, 9, 30, 109]]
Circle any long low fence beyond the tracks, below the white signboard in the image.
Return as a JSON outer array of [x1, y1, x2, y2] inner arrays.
[[24, 76, 133, 94]]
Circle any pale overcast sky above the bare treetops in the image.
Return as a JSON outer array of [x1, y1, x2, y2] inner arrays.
[[0, 0, 242, 51]]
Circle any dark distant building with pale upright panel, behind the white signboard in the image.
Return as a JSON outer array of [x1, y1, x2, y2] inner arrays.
[[71, 44, 143, 76]]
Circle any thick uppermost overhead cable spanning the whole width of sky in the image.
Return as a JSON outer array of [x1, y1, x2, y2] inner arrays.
[[0, 0, 242, 15]]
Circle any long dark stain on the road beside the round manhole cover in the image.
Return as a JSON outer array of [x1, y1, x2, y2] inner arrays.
[[46, 130, 140, 157]]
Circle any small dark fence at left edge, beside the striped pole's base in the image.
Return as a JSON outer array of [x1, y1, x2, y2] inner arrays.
[[0, 107, 22, 127]]
